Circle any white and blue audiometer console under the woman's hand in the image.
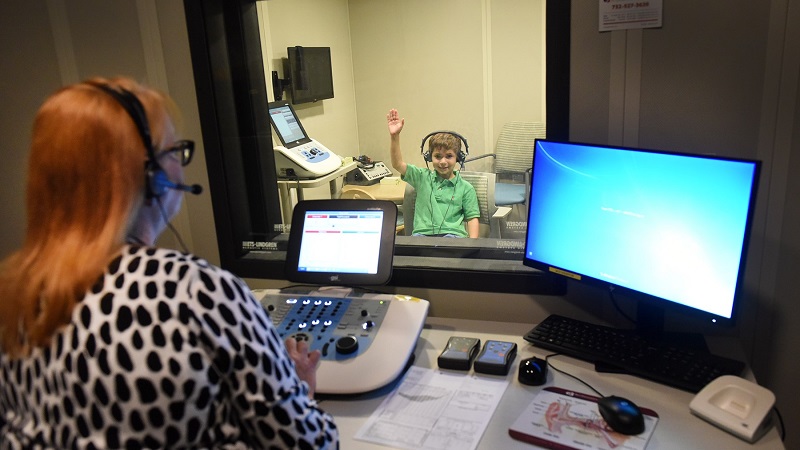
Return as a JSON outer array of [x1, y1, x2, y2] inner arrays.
[[253, 289, 429, 394]]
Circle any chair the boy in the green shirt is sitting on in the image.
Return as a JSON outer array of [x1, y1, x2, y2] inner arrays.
[[402, 171, 511, 239]]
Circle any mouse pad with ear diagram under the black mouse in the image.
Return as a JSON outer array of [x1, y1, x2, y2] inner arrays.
[[508, 387, 658, 450]]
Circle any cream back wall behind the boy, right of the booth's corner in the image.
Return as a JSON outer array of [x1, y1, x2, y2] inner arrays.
[[349, 0, 545, 165]]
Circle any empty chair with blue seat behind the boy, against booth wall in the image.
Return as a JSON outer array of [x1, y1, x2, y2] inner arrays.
[[466, 122, 547, 214]]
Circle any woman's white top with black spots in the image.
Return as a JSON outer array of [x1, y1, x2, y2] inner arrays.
[[0, 247, 338, 449]]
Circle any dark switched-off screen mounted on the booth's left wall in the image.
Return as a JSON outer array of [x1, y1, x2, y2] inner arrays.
[[286, 46, 333, 104]]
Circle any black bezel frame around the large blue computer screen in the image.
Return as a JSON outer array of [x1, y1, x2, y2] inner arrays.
[[522, 139, 761, 331]]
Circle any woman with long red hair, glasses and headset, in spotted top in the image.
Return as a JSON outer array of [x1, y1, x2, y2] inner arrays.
[[0, 78, 338, 448]]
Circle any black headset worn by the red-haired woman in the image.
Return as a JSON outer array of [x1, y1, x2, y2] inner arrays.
[[92, 83, 171, 199]]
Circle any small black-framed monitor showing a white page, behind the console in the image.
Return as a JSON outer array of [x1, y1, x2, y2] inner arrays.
[[286, 200, 397, 285]]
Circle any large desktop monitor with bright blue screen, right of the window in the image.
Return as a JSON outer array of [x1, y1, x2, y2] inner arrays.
[[524, 140, 760, 323]]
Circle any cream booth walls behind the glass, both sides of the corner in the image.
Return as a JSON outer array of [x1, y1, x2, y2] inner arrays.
[[259, 0, 545, 169]]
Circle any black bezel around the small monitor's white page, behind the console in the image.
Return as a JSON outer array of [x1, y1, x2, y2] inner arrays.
[[285, 199, 397, 286]]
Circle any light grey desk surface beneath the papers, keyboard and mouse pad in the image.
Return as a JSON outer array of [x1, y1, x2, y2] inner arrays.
[[320, 317, 784, 450]]
